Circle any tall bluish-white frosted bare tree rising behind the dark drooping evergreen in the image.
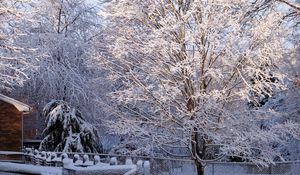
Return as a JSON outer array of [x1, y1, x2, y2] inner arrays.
[[12, 0, 108, 133]]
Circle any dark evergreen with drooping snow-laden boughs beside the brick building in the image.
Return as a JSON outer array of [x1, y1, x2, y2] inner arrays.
[[39, 100, 102, 153]]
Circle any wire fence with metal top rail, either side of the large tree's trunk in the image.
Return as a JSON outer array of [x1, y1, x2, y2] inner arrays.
[[150, 159, 300, 175]]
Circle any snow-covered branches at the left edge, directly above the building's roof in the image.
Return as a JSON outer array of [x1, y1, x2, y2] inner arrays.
[[0, 0, 34, 91]]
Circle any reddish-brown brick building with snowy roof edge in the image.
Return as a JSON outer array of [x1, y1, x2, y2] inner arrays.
[[0, 94, 30, 151]]
